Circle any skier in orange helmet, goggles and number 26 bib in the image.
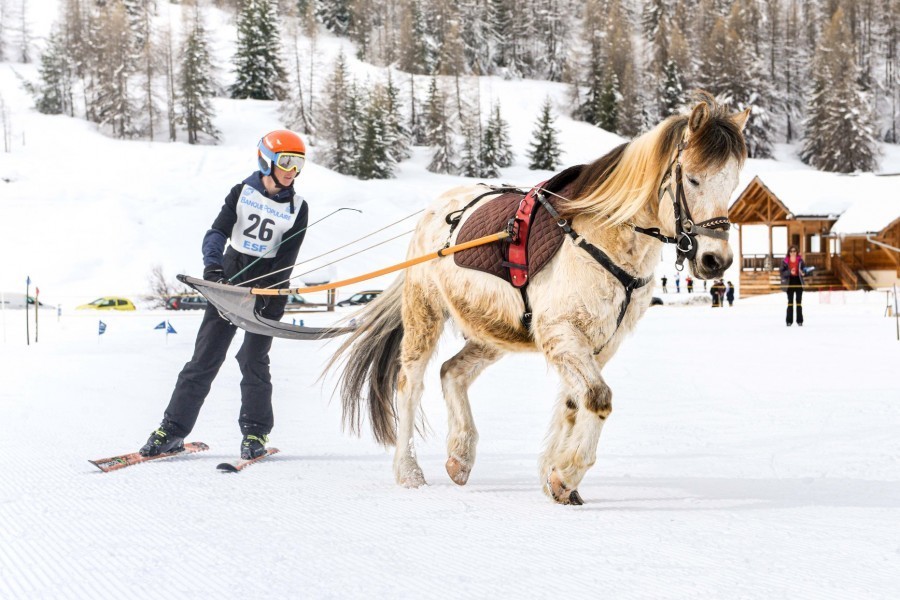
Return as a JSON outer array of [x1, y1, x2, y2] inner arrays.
[[140, 129, 309, 460]]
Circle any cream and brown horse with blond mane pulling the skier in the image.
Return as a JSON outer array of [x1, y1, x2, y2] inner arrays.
[[325, 92, 749, 505]]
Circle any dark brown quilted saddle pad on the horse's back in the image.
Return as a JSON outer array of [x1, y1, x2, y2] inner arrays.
[[453, 165, 581, 282]]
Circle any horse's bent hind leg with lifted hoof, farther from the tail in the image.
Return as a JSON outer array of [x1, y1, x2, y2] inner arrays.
[[441, 340, 503, 485]]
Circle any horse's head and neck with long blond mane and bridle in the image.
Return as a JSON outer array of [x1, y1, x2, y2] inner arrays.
[[560, 92, 750, 279]]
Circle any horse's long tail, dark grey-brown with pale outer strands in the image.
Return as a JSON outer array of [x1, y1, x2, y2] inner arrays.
[[325, 274, 406, 446]]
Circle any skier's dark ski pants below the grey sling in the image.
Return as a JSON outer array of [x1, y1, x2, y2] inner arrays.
[[165, 304, 274, 436]]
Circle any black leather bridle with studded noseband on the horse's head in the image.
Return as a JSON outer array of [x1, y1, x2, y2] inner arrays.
[[631, 140, 731, 271]]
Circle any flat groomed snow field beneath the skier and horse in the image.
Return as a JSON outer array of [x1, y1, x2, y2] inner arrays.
[[0, 292, 900, 598]]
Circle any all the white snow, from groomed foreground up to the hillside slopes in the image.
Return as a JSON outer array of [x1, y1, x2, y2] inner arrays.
[[0, 2, 900, 599]]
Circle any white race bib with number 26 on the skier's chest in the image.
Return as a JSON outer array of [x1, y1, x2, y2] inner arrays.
[[231, 184, 299, 258]]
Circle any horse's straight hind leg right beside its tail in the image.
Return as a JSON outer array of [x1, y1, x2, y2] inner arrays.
[[394, 280, 444, 488]]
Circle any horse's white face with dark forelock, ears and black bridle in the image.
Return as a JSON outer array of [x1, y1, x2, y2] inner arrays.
[[658, 92, 750, 279]]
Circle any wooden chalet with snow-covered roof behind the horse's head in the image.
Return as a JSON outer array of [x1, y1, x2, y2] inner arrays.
[[728, 171, 900, 297]]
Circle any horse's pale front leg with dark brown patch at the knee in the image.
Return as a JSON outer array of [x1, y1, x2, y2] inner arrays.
[[540, 324, 612, 504]]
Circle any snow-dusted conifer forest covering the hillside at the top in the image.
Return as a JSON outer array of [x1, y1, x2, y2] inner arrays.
[[7, 0, 900, 173]]
